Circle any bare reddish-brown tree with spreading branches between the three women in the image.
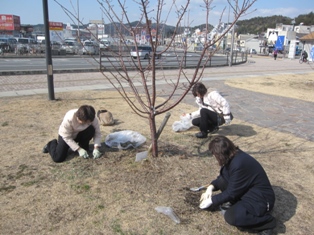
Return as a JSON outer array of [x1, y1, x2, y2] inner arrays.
[[55, 0, 256, 157]]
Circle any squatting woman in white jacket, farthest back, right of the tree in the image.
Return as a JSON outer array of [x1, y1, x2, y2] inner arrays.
[[183, 82, 233, 138]]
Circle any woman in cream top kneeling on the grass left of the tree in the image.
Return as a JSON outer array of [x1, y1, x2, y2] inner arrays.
[[43, 105, 102, 162]]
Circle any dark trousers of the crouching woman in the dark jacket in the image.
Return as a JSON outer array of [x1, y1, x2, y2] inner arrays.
[[217, 176, 276, 231]]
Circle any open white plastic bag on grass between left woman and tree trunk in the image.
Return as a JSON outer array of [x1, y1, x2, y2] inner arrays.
[[105, 130, 146, 149]]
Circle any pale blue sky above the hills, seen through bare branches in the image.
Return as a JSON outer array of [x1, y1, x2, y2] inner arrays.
[[0, 0, 314, 26]]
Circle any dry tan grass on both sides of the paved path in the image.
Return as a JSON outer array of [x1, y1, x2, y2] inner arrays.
[[0, 74, 314, 235]]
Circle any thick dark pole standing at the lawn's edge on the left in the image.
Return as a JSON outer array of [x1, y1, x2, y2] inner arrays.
[[43, 0, 55, 100]]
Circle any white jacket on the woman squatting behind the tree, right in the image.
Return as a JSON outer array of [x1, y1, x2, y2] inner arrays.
[[191, 91, 230, 119]]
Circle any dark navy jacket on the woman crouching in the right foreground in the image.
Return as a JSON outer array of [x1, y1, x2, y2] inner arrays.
[[212, 150, 275, 214]]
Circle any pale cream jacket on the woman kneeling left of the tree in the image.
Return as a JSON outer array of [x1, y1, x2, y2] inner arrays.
[[59, 109, 101, 151]]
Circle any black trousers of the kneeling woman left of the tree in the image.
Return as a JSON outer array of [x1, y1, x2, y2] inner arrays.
[[47, 125, 95, 162]]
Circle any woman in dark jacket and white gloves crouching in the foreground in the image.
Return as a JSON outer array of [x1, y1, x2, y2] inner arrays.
[[200, 135, 276, 234]]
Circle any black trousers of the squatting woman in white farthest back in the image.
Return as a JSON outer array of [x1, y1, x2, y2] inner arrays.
[[192, 108, 218, 132]]
